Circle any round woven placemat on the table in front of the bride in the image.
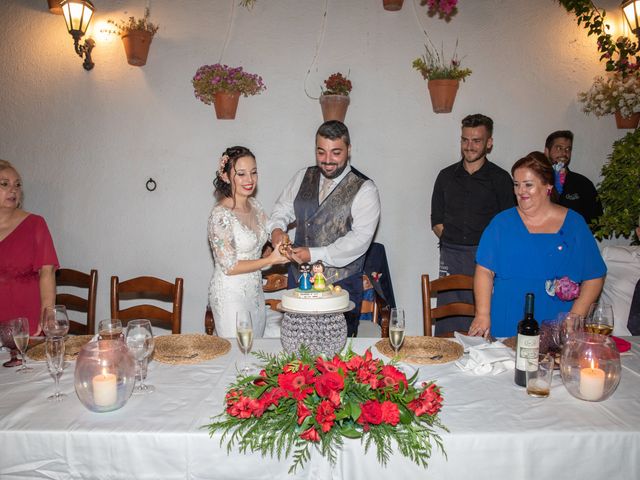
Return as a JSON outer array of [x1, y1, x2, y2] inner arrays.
[[153, 333, 231, 365]]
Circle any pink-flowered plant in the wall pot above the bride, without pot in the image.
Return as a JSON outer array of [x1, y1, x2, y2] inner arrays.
[[191, 63, 267, 105]]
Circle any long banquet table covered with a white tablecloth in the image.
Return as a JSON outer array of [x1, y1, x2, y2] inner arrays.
[[0, 337, 640, 480]]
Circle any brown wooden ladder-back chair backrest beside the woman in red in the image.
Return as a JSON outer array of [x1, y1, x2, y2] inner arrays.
[[56, 268, 98, 335]]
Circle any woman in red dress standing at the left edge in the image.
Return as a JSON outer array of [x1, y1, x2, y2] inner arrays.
[[0, 160, 58, 335]]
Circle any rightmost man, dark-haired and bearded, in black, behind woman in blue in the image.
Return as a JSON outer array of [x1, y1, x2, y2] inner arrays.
[[544, 130, 602, 230]]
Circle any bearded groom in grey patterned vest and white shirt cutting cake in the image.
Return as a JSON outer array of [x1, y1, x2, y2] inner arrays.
[[267, 120, 380, 337]]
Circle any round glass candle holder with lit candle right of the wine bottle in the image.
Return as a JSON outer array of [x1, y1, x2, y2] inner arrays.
[[560, 333, 620, 402]]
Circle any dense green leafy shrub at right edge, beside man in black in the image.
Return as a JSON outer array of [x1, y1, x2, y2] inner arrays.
[[593, 129, 640, 244]]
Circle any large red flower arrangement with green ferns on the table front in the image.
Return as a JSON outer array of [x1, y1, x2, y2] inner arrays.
[[207, 347, 447, 473]]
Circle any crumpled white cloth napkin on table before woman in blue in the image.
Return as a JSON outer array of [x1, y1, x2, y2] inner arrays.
[[454, 332, 515, 375]]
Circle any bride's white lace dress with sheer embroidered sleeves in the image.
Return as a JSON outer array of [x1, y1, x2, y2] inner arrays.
[[209, 198, 268, 337]]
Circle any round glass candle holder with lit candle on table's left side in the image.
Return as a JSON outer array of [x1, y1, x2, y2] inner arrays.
[[74, 340, 136, 412]]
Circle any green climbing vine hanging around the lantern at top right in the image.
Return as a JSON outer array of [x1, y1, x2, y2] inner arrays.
[[558, 0, 640, 77]]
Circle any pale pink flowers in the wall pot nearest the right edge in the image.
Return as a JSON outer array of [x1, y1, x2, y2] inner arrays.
[[578, 73, 640, 117]]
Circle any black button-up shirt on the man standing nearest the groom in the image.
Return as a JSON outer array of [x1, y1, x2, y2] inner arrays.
[[431, 160, 515, 245]]
